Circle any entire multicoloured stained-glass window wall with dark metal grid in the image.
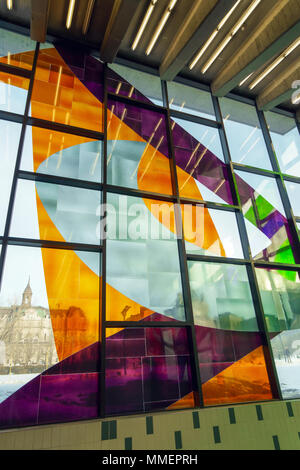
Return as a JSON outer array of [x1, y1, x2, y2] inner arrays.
[[0, 18, 300, 448]]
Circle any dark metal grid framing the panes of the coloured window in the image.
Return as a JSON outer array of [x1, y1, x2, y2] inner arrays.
[[0, 29, 300, 426]]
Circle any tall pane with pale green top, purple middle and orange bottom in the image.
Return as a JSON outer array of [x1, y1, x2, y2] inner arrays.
[[188, 261, 272, 406]]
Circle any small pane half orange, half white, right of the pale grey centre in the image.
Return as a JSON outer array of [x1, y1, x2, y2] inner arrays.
[[182, 204, 243, 258]]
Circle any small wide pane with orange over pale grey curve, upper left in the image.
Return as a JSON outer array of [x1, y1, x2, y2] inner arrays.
[[21, 126, 103, 182]]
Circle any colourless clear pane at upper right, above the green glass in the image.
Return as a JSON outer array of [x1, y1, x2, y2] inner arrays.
[[220, 98, 272, 170]]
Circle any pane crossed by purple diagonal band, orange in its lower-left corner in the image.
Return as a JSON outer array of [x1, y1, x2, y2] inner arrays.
[[171, 119, 233, 204]]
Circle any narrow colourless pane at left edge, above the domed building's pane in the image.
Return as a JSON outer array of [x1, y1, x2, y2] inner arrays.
[[0, 120, 22, 236]]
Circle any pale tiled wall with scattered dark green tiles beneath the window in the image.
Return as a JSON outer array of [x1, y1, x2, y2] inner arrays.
[[0, 401, 300, 450]]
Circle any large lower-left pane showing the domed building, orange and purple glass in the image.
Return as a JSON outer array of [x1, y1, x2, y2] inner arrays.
[[0, 246, 100, 428]]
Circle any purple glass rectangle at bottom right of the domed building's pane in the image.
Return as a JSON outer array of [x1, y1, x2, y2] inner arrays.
[[38, 373, 100, 424]]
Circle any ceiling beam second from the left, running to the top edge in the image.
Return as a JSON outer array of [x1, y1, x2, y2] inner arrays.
[[100, 0, 140, 63]]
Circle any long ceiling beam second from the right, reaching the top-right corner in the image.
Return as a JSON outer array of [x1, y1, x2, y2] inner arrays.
[[212, 0, 300, 96]]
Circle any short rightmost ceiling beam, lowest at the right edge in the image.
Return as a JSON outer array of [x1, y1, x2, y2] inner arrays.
[[256, 58, 300, 111]]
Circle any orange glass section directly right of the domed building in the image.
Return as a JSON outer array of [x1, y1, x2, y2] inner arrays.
[[42, 248, 101, 361]]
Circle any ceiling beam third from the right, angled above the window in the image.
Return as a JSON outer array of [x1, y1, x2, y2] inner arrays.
[[159, 0, 236, 80]]
